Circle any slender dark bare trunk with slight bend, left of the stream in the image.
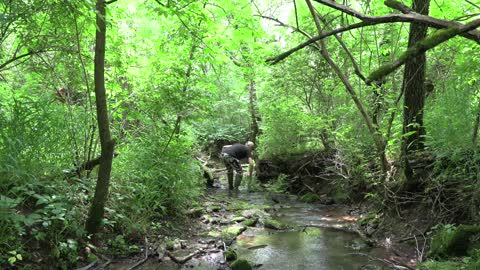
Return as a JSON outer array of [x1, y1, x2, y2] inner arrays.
[[86, 0, 115, 234]]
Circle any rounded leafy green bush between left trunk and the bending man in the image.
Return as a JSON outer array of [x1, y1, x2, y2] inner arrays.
[[112, 129, 204, 224]]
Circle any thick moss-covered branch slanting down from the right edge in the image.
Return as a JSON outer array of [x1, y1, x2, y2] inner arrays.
[[366, 19, 480, 84]]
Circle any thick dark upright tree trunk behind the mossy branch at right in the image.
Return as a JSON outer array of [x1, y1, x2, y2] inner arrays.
[[402, 0, 430, 189]]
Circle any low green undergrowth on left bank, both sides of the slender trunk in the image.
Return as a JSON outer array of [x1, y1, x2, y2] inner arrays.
[[0, 99, 204, 269]]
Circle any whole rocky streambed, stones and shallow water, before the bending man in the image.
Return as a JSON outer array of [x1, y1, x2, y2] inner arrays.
[[106, 188, 411, 270]]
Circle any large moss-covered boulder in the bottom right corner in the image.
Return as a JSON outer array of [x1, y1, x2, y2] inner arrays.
[[430, 225, 480, 258]]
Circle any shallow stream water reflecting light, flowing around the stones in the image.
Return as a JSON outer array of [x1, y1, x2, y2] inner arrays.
[[110, 189, 392, 270]]
